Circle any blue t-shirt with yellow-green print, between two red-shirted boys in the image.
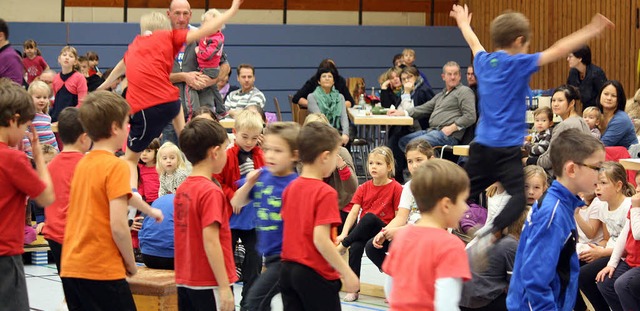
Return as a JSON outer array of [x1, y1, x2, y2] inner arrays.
[[240, 169, 298, 257]]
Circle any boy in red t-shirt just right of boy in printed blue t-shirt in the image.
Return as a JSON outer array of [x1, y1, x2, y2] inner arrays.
[[280, 122, 359, 310]]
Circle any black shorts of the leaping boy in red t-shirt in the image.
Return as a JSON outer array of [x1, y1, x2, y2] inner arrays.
[[127, 100, 181, 152]]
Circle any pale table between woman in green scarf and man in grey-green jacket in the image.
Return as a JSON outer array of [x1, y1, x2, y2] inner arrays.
[[349, 108, 414, 147]]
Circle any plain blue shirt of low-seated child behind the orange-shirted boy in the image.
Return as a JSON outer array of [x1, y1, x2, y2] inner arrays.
[[138, 194, 175, 258]]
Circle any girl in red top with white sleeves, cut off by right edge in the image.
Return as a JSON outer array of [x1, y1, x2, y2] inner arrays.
[[596, 176, 640, 310]]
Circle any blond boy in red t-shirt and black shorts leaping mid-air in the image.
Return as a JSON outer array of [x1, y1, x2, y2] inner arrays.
[[98, 0, 243, 212]]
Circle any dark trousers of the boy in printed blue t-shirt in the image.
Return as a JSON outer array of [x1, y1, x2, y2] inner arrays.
[[247, 255, 282, 311]]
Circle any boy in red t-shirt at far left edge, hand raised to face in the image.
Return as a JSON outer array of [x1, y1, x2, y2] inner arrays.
[[0, 79, 54, 310]]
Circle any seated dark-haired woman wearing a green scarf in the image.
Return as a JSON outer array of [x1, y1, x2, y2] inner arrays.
[[307, 68, 349, 145]]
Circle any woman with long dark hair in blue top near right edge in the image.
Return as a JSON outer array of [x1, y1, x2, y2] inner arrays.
[[597, 80, 638, 149]]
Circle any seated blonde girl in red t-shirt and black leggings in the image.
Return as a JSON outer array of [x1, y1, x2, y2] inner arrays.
[[336, 147, 402, 301]]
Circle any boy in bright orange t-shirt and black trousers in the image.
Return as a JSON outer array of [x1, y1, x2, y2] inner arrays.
[[60, 91, 162, 310]]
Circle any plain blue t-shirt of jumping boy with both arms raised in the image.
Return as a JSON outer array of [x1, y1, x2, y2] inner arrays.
[[473, 51, 540, 147]]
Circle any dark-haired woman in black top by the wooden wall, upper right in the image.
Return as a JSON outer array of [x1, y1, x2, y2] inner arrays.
[[567, 45, 607, 113]]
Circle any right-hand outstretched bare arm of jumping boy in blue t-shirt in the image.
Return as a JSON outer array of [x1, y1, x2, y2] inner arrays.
[[538, 14, 614, 66]]
